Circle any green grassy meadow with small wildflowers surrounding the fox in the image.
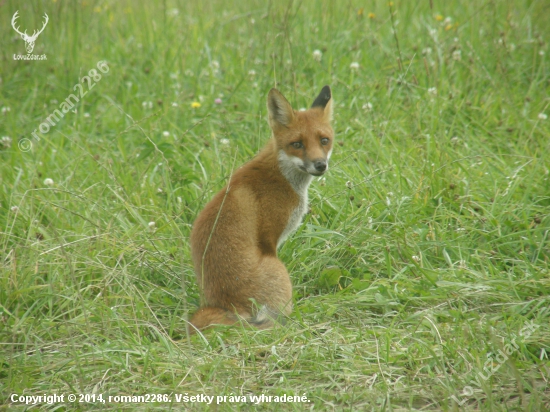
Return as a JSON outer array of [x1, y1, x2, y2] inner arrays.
[[0, 0, 550, 411]]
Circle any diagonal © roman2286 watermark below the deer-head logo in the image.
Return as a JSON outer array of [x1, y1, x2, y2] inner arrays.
[[17, 60, 109, 152]]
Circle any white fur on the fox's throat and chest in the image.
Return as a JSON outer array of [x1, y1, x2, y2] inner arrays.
[[277, 150, 313, 247]]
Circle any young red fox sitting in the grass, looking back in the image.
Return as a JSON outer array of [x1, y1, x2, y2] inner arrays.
[[190, 86, 334, 333]]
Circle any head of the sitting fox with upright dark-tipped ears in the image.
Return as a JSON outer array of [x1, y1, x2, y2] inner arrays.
[[267, 86, 334, 176]]
